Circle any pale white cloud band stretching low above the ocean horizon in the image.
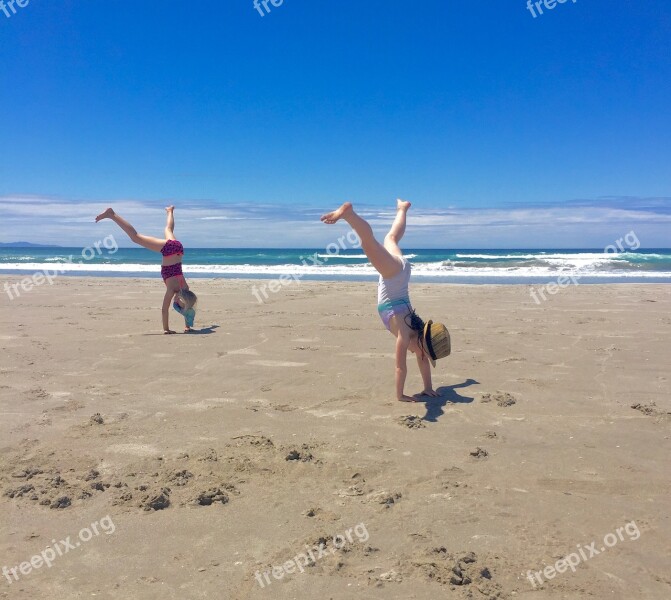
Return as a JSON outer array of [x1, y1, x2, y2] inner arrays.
[[0, 196, 671, 248]]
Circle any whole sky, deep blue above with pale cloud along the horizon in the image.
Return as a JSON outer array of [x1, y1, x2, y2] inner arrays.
[[0, 0, 671, 247]]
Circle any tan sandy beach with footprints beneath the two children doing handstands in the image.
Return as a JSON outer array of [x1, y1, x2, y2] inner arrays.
[[0, 277, 671, 600]]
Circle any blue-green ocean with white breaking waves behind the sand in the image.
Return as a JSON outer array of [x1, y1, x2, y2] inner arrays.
[[0, 247, 671, 284]]
